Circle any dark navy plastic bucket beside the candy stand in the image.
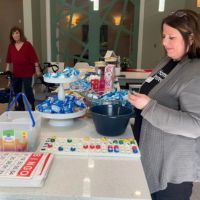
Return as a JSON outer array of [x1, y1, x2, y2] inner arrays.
[[90, 105, 134, 136]]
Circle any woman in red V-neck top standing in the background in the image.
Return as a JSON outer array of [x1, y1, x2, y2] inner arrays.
[[6, 26, 40, 110]]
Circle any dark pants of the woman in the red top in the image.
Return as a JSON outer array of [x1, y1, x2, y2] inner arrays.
[[13, 77, 35, 110]]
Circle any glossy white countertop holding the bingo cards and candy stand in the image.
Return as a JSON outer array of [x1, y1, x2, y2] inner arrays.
[[0, 118, 151, 200]]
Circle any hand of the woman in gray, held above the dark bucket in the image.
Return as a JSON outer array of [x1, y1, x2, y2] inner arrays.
[[128, 92, 151, 110]]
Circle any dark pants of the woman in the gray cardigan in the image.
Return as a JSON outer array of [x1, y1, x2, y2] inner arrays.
[[151, 182, 193, 200]]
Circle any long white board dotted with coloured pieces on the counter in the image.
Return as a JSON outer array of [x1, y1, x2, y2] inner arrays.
[[38, 137, 140, 158]]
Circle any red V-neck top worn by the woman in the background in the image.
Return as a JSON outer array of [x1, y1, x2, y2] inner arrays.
[[6, 41, 38, 78]]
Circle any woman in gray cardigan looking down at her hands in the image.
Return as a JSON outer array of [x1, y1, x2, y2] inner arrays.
[[128, 10, 200, 200]]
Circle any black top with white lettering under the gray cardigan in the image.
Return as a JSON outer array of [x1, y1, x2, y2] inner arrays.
[[133, 60, 179, 144]]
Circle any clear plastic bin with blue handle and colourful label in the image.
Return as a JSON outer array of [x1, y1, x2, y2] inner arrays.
[[0, 93, 41, 151]]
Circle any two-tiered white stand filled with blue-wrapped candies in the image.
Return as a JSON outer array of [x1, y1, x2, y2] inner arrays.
[[36, 67, 86, 126]]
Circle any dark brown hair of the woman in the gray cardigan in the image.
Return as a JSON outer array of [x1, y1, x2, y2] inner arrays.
[[161, 9, 200, 58]]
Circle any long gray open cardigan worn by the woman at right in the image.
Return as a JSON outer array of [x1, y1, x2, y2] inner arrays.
[[140, 57, 200, 193]]
